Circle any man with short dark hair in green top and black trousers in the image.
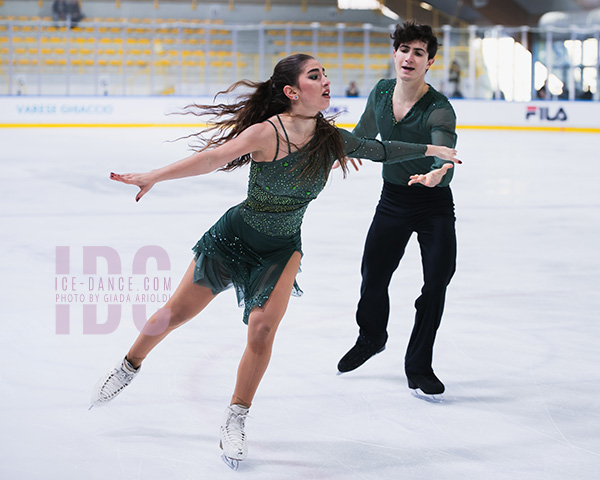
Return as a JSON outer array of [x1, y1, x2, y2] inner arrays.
[[338, 22, 456, 400]]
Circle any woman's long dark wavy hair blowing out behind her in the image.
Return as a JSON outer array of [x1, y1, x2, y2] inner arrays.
[[184, 54, 348, 180]]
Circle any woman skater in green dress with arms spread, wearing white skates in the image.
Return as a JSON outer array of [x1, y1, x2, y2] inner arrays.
[[92, 54, 458, 468]]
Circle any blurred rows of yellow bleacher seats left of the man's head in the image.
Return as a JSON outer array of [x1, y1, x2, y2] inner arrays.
[[0, 0, 398, 95]]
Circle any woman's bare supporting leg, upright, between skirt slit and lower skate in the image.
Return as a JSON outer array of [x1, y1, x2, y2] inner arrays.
[[231, 252, 301, 407]]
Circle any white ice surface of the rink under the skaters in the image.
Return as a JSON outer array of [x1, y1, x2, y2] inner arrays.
[[0, 128, 600, 480]]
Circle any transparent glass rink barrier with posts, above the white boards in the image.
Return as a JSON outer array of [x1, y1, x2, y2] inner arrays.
[[0, 19, 599, 101]]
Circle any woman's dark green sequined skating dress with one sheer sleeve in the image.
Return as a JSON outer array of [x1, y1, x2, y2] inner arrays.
[[193, 116, 427, 324]]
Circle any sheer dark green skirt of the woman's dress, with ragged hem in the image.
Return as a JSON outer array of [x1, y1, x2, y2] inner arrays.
[[192, 205, 302, 324]]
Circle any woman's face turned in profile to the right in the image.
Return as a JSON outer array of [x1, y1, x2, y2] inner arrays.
[[292, 58, 331, 114]]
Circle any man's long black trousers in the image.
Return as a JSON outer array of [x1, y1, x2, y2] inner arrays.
[[356, 182, 456, 374]]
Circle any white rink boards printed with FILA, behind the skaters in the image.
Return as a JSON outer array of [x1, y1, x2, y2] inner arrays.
[[0, 96, 600, 133]]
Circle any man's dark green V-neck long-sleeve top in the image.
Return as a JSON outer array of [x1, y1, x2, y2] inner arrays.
[[353, 79, 457, 187]]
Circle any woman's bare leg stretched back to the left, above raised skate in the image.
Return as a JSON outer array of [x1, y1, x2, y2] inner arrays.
[[126, 261, 215, 368]]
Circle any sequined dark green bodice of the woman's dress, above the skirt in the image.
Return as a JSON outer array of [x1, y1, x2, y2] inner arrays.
[[240, 151, 325, 236]]
